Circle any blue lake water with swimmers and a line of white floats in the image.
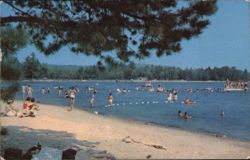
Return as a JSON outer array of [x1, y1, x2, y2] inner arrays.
[[1, 82, 250, 141]]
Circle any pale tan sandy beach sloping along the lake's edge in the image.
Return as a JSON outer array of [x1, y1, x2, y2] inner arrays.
[[1, 102, 250, 159]]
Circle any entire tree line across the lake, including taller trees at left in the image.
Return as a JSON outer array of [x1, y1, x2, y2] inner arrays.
[[1, 54, 250, 81]]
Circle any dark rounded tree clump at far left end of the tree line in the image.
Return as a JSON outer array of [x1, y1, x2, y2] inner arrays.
[[1, 55, 21, 80]]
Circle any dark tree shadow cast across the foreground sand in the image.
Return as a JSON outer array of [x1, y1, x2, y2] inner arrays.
[[1, 126, 115, 159]]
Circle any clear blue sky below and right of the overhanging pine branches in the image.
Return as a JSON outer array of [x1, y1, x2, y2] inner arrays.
[[2, 0, 250, 71]]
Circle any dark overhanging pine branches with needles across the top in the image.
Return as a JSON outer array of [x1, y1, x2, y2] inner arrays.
[[1, 0, 217, 63]]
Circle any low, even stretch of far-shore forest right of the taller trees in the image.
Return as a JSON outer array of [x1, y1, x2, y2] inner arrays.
[[42, 63, 250, 81]]
